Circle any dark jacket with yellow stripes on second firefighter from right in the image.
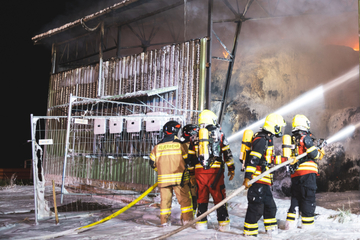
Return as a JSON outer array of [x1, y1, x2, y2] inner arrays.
[[245, 131, 287, 186]]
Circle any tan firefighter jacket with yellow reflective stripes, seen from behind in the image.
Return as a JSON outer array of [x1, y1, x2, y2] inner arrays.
[[149, 134, 189, 187]]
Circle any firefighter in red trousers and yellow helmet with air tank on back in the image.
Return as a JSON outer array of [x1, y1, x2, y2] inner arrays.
[[188, 110, 235, 231]]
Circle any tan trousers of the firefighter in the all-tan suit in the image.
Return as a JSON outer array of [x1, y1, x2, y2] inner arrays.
[[160, 184, 194, 224]]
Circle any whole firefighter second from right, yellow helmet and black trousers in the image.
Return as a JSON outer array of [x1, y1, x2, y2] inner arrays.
[[243, 113, 287, 236]]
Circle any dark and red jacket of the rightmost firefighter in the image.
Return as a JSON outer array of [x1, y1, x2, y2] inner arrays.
[[291, 131, 320, 178]]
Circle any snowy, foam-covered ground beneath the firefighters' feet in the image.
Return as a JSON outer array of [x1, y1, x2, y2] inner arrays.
[[0, 186, 360, 240]]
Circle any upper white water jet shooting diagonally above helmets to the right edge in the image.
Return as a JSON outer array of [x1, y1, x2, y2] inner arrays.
[[228, 66, 359, 143]]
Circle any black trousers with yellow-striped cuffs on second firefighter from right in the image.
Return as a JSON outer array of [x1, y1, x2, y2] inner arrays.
[[244, 183, 277, 236]]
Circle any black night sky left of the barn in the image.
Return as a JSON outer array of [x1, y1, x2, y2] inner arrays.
[[0, 0, 118, 168]]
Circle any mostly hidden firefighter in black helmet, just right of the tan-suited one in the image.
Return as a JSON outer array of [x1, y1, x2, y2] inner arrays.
[[182, 124, 199, 216]]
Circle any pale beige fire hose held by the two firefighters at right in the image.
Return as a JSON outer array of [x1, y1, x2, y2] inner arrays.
[[154, 152, 307, 239]]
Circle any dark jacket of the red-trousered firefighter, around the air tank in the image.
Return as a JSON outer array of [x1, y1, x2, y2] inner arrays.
[[188, 126, 235, 175]]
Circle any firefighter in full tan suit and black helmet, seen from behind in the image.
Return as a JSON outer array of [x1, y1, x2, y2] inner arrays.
[[149, 121, 193, 227]]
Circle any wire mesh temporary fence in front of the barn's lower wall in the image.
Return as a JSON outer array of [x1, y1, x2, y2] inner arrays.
[[32, 95, 194, 201]]
